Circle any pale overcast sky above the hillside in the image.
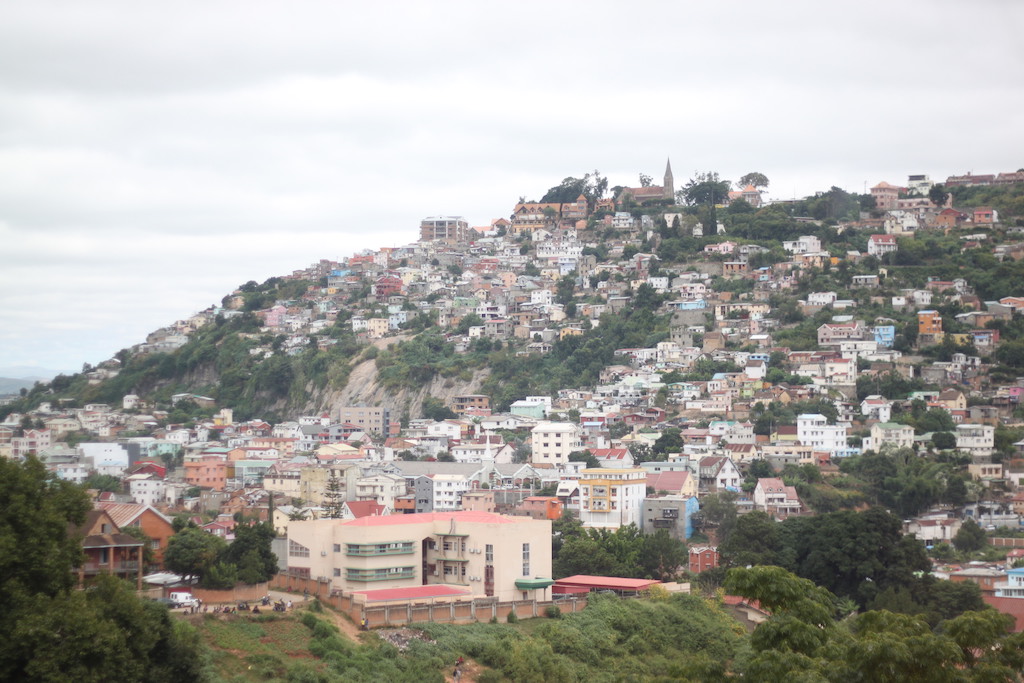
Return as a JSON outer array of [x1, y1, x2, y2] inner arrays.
[[0, 0, 1024, 372]]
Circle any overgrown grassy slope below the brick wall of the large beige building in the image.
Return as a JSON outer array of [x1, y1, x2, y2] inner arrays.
[[191, 596, 743, 683]]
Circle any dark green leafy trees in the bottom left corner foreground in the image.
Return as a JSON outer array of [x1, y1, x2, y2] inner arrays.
[[0, 457, 207, 683]]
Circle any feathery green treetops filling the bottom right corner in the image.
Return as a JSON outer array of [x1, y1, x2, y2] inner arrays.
[[725, 566, 1024, 683]]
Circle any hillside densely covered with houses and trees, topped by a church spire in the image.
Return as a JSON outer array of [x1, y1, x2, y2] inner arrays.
[[0, 163, 1024, 628]]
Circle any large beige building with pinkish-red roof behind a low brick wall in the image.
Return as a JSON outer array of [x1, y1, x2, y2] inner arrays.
[[288, 511, 553, 600]]
